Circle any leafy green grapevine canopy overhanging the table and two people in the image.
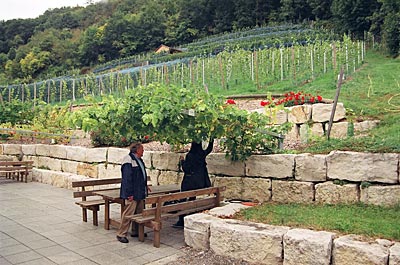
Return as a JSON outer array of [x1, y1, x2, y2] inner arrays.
[[69, 83, 290, 160]]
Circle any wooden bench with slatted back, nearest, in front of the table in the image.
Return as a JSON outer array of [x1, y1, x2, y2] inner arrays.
[[131, 187, 225, 247]]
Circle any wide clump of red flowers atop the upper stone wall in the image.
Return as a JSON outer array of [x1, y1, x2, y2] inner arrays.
[[260, 91, 322, 107]]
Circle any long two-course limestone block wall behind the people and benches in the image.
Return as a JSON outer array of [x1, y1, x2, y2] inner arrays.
[[0, 144, 400, 205]]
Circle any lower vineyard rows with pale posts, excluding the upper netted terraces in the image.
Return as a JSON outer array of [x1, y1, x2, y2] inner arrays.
[[0, 35, 365, 103]]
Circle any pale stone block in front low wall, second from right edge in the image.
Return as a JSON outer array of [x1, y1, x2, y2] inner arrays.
[[332, 235, 389, 265]]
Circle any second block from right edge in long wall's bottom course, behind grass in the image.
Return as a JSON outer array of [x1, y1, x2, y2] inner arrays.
[[315, 181, 360, 204]]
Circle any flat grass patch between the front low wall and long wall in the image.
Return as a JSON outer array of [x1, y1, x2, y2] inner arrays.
[[235, 203, 400, 241]]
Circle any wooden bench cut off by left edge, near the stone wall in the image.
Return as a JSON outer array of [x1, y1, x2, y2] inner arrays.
[[0, 160, 33, 182]]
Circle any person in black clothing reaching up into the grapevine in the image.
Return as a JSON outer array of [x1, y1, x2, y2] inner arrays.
[[173, 139, 214, 228]]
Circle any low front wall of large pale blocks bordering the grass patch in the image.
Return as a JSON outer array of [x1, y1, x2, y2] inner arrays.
[[184, 208, 400, 265]]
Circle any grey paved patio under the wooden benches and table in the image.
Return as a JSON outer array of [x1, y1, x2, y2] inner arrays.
[[0, 178, 185, 265]]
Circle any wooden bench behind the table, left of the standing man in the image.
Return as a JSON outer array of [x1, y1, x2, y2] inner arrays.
[[72, 178, 121, 226]]
